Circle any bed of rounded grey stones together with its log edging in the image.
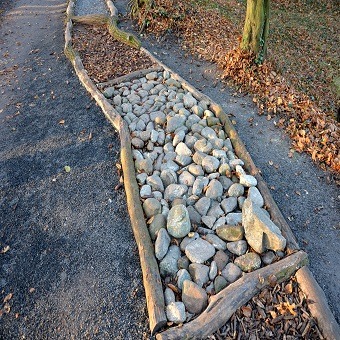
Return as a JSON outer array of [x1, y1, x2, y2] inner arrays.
[[65, 1, 339, 339]]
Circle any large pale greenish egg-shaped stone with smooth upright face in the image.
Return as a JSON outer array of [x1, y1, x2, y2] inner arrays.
[[167, 204, 191, 238]]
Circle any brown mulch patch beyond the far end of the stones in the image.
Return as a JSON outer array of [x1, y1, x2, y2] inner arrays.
[[73, 25, 154, 83]]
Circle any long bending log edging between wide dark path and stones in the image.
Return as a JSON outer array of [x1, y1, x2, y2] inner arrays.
[[65, 0, 167, 334]]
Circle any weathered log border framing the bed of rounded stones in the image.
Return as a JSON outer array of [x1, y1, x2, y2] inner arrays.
[[64, 0, 340, 340]]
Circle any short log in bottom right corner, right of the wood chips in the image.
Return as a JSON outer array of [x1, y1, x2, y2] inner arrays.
[[295, 267, 340, 340]]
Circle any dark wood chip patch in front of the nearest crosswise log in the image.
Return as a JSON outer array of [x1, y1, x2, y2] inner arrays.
[[208, 277, 324, 340]]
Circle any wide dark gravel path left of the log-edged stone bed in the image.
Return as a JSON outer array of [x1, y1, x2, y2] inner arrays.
[[0, 0, 148, 339]]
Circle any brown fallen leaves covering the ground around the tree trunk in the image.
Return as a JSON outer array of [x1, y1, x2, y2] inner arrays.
[[132, 0, 340, 175]]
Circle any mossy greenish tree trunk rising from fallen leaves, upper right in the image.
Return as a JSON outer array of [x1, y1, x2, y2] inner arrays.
[[241, 0, 269, 64]]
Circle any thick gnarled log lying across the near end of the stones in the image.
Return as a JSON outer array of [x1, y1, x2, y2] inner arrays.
[[156, 251, 308, 340]]
